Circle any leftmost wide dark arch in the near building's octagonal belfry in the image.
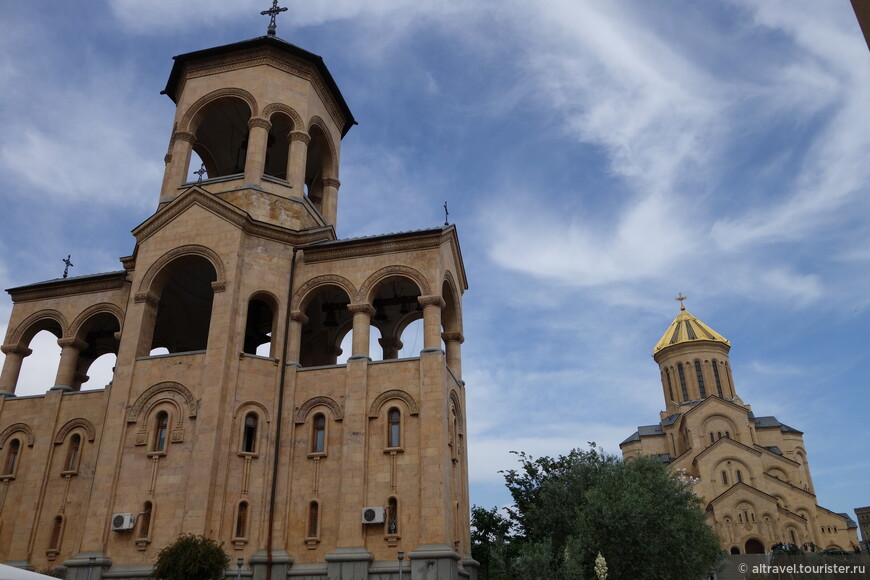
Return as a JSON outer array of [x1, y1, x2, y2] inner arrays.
[[190, 97, 251, 179]]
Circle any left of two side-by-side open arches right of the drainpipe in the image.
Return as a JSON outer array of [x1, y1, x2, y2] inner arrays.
[[299, 285, 353, 367]]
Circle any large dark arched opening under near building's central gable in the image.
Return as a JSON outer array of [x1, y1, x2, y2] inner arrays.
[[150, 256, 217, 354]]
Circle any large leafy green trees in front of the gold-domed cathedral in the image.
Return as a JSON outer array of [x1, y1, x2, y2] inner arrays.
[[472, 444, 721, 580]]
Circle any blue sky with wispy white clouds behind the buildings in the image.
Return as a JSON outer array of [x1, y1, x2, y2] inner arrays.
[[0, 0, 870, 517]]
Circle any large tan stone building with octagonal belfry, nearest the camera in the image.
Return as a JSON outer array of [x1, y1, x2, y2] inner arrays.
[[0, 15, 476, 580]]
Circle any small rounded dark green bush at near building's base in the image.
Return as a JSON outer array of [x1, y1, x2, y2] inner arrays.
[[151, 534, 230, 580]]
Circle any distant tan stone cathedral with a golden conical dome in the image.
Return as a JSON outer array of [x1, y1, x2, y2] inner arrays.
[[620, 302, 858, 554]]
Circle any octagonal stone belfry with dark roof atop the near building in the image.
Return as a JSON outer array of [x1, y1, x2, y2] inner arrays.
[[160, 35, 356, 230]]
